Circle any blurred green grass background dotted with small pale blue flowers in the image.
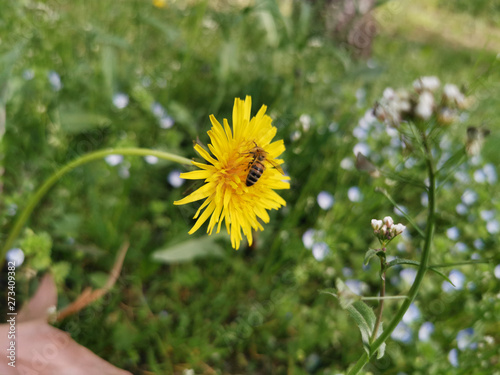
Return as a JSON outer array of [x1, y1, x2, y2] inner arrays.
[[0, 0, 500, 374]]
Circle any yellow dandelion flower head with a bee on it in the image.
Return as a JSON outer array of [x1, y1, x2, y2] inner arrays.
[[174, 96, 290, 249]]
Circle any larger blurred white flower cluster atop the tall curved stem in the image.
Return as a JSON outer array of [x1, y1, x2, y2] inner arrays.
[[373, 76, 472, 127]]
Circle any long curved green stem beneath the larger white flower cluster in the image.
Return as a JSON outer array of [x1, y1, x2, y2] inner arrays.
[[348, 134, 436, 375]]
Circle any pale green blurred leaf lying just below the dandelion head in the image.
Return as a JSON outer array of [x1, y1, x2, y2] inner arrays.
[[152, 235, 227, 263]]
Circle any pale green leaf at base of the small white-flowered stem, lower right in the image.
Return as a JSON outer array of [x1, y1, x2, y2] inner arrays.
[[323, 279, 385, 359]]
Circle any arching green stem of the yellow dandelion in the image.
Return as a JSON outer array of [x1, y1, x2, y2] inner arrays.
[[0, 147, 191, 265]]
